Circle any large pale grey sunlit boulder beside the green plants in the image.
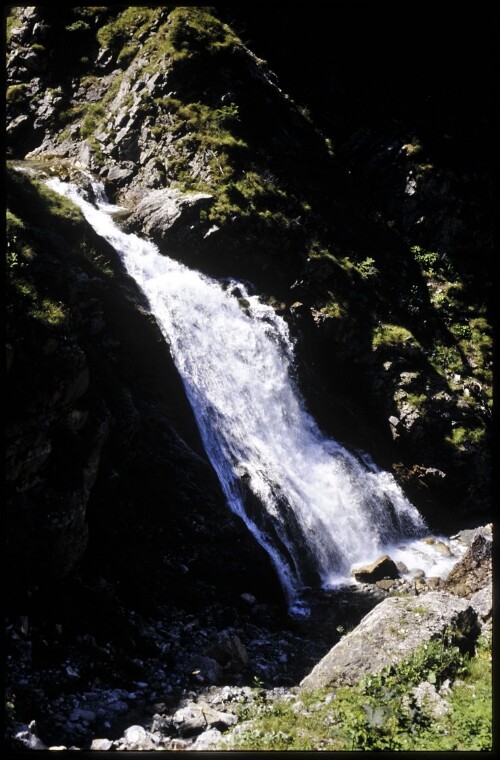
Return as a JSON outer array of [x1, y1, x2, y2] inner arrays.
[[300, 591, 479, 690]]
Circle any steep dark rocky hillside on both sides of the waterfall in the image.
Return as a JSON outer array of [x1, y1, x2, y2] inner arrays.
[[6, 5, 492, 743]]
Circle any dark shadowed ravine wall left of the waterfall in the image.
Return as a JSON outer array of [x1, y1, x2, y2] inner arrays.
[[7, 166, 286, 606]]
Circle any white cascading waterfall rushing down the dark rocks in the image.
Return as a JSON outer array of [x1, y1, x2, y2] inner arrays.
[[47, 179, 425, 608]]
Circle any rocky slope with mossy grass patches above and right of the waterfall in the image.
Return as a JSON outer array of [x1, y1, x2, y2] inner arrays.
[[7, 7, 491, 528]]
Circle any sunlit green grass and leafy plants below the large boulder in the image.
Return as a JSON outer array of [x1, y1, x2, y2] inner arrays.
[[228, 636, 492, 751]]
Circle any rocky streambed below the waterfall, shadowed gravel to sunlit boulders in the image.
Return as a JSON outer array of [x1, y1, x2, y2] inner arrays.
[[7, 526, 492, 751]]
